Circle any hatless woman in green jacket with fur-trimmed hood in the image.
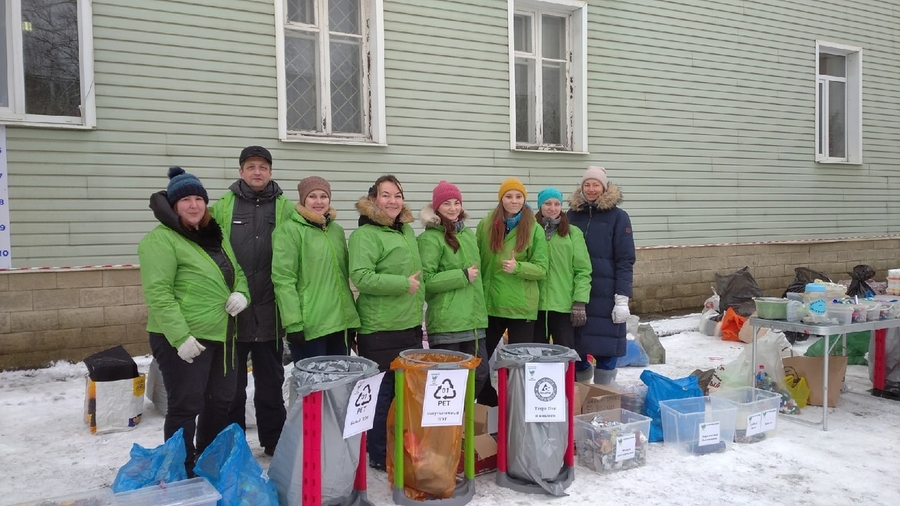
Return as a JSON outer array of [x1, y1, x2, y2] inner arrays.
[[350, 175, 424, 470]]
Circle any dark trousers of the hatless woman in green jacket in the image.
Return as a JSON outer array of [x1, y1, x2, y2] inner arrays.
[[356, 327, 422, 466]]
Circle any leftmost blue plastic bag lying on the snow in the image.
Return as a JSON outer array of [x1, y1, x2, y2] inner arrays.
[[111, 429, 187, 494]]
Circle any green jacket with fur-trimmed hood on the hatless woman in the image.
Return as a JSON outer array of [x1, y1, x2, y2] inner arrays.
[[350, 197, 426, 334]]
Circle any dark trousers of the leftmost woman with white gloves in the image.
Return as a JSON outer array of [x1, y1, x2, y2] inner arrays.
[[150, 332, 237, 469]]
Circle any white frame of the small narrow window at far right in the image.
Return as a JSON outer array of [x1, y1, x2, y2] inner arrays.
[[815, 40, 863, 164]]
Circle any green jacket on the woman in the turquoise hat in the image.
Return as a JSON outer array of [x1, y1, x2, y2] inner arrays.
[[538, 226, 591, 313]]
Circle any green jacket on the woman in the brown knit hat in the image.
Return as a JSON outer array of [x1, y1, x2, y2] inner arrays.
[[272, 204, 359, 341]]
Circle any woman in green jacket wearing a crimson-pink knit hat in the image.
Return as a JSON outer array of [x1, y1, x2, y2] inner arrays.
[[416, 181, 490, 398]]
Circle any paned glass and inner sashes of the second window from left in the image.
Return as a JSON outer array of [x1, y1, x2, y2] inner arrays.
[[284, 0, 369, 138]]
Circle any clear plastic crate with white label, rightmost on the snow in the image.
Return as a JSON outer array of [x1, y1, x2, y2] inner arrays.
[[711, 387, 781, 443]]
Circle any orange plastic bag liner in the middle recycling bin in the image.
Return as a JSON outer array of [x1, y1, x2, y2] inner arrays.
[[386, 350, 481, 501]]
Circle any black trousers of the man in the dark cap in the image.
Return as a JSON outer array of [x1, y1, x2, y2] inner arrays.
[[228, 338, 287, 447]]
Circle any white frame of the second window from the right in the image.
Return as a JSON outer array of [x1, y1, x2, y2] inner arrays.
[[507, 0, 588, 154]]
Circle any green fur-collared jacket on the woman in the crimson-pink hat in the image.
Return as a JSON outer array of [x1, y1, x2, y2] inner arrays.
[[417, 204, 487, 344]]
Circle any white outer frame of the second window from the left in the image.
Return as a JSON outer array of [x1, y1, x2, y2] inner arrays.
[[275, 0, 387, 145]]
